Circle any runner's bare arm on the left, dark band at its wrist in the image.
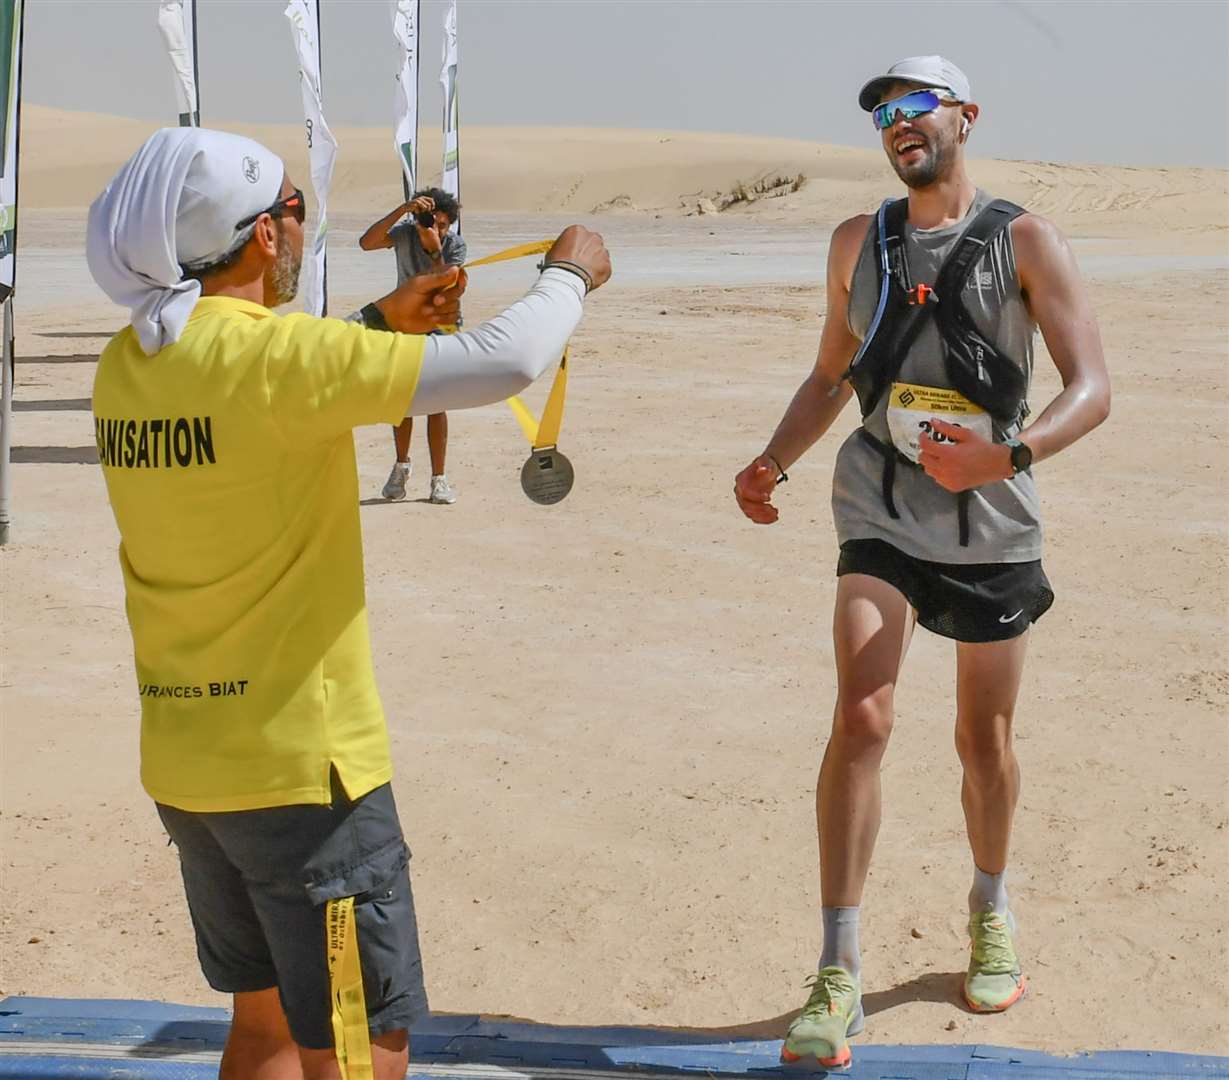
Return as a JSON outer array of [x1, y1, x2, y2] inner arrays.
[[734, 216, 870, 525]]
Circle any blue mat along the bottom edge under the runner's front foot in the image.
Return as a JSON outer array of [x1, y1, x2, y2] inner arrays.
[[0, 998, 1229, 1080]]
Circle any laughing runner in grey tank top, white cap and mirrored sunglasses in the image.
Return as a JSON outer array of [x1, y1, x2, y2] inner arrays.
[[734, 57, 1110, 1068]]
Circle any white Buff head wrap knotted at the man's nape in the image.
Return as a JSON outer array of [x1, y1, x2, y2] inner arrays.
[[85, 128, 285, 356]]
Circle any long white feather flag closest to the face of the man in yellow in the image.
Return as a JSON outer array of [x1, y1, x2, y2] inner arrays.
[[286, 0, 337, 315]]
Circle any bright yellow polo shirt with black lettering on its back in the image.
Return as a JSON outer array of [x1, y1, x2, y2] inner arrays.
[[93, 296, 424, 811]]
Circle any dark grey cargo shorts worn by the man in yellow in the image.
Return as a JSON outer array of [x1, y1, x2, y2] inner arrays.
[[157, 779, 428, 1049]]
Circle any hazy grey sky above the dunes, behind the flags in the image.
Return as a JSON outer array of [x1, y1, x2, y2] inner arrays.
[[16, 0, 1229, 167]]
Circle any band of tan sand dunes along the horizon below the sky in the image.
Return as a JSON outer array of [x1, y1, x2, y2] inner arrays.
[[22, 106, 1229, 238]]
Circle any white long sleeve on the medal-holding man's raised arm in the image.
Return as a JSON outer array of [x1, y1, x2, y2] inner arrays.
[[406, 269, 585, 417]]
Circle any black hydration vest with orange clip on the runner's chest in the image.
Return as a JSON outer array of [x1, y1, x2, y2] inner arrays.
[[843, 199, 1029, 547]]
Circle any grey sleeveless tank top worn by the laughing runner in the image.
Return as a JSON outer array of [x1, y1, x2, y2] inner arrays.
[[832, 189, 1041, 564]]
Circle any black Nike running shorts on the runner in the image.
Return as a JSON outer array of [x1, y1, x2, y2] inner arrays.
[[837, 539, 1054, 643]]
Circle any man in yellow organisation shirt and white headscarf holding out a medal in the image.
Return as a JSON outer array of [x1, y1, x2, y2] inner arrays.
[[87, 128, 610, 1080]]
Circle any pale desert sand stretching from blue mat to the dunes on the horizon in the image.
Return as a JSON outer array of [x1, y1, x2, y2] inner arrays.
[[0, 107, 1229, 1053]]
